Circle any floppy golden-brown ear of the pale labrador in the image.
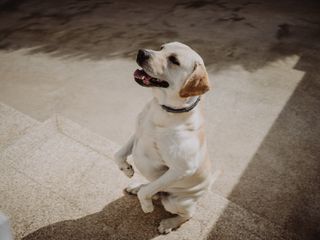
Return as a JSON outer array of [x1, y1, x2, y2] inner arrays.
[[179, 64, 210, 98]]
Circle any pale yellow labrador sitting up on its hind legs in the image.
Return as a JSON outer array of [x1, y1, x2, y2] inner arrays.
[[115, 42, 211, 233]]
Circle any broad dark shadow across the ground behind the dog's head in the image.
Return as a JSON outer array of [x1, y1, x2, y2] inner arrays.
[[0, 0, 320, 70]]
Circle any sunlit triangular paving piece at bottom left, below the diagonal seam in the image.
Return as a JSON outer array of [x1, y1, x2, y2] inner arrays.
[[0, 163, 83, 239]]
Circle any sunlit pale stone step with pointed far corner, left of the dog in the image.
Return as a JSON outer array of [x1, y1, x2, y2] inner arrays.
[[0, 116, 127, 239]]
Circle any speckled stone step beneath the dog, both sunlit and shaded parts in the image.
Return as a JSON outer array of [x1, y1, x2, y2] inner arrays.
[[0, 104, 298, 240]]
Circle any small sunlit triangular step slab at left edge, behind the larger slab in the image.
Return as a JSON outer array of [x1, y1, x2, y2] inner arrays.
[[0, 103, 39, 152]]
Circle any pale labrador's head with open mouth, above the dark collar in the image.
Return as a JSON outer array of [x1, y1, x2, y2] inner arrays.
[[134, 42, 210, 103]]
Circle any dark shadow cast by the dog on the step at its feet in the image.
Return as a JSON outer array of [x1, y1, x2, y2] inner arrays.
[[23, 195, 171, 240]]
